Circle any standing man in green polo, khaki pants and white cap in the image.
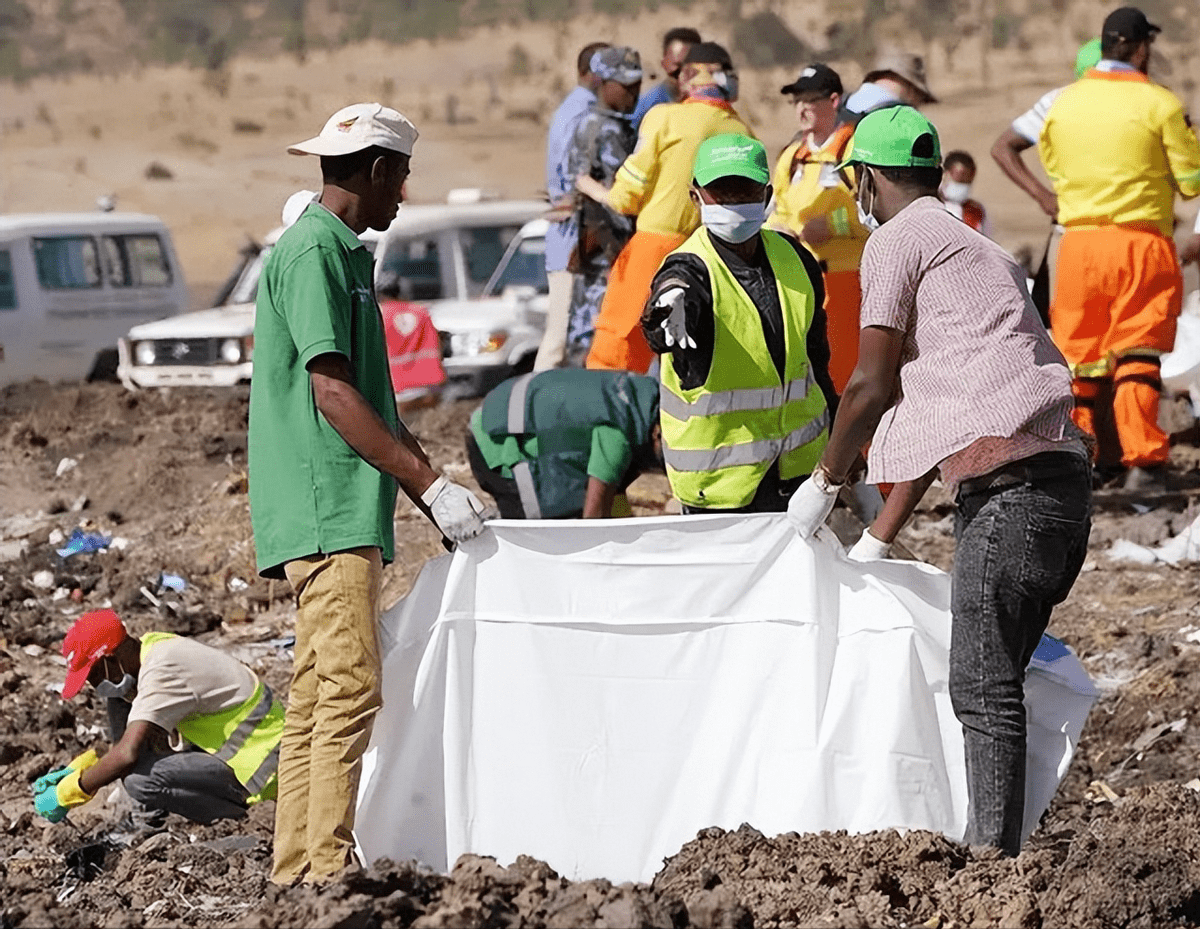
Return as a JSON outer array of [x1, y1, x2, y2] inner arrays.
[[250, 103, 485, 883]]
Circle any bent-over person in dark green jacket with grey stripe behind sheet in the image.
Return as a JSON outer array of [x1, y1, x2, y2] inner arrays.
[[467, 368, 662, 520]]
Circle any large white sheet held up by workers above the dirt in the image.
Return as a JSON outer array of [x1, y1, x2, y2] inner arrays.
[[356, 515, 1096, 881]]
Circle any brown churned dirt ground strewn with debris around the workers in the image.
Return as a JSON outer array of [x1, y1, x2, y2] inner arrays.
[[0, 384, 1200, 929]]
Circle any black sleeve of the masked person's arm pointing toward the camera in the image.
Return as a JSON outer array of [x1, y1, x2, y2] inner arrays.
[[642, 254, 716, 390]]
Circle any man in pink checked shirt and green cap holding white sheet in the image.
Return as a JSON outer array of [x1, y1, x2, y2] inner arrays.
[[788, 107, 1091, 855]]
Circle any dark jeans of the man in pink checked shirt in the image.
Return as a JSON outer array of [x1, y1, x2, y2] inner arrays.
[[949, 455, 1092, 855]]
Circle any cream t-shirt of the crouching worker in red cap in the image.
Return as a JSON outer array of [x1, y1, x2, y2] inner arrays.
[[130, 636, 258, 732]]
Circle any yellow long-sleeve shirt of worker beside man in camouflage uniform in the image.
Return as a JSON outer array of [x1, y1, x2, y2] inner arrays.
[[608, 100, 755, 235]]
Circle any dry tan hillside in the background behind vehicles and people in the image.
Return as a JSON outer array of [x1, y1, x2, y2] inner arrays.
[[0, 0, 1195, 304]]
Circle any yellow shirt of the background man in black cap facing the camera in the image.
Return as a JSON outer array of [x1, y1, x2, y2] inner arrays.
[[767, 126, 870, 271]]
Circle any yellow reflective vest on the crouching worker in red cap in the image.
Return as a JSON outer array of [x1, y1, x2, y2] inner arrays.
[[142, 633, 283, 803]]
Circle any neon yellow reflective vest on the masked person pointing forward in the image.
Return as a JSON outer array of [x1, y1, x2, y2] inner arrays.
[[660, 227, 829, 510]]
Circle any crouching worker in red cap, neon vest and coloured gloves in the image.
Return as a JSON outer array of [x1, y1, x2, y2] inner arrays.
[[32, 610, 283, 823]]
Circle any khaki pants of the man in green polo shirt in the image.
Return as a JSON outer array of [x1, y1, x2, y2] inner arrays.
[[271, 547, 383, 883]]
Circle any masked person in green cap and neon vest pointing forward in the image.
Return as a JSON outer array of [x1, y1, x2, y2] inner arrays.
[[642, 133, 838, 513]]
